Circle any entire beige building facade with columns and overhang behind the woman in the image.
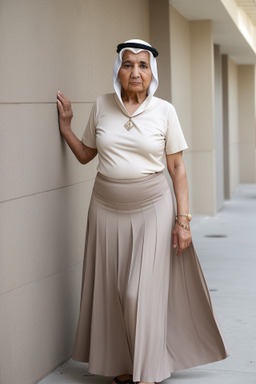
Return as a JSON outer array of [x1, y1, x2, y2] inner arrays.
[[0, 0, 256, 384]]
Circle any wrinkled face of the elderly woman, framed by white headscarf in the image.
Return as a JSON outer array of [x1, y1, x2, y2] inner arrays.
[[118, 50, 152, 93]]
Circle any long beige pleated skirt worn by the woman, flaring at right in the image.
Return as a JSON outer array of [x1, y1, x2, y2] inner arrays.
[[73, 173, 227, 382]]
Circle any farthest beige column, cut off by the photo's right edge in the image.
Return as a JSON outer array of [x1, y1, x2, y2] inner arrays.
[[238, 65, 256, 183]]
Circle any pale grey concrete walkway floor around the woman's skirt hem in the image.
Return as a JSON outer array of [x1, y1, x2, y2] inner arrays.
[[40, 184, 256, 384]]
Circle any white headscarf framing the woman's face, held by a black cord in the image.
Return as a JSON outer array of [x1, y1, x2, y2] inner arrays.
[[113, 39, 158, 103]]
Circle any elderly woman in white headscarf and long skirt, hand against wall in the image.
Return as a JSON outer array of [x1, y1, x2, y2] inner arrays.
[[58, 40, 227, 384]]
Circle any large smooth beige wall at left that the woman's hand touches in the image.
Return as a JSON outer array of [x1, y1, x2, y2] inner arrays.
[[0, 0, 150, 384]]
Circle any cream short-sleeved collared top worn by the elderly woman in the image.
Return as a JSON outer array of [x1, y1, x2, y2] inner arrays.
[[82, 94, 187, 179]]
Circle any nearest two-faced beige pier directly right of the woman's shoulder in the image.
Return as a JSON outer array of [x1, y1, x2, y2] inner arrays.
[[170, 6, 216, 215]]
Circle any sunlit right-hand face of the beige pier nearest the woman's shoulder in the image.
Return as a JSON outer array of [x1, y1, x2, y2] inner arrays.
[[190, 21, 216, 215]]
